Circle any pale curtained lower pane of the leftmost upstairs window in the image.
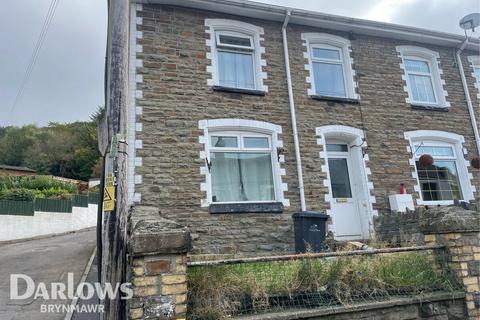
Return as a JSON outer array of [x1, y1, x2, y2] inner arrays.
[[218, 51, 255, 89]]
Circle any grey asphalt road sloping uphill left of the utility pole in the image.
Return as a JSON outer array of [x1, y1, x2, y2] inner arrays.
[[0, 230, 96, 320]]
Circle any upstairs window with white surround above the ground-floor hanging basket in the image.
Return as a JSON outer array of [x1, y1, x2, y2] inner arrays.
[[397, 46, 450, 108]]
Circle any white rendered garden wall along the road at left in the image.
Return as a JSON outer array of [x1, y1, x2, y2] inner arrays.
[[0, 202, 97, 241]]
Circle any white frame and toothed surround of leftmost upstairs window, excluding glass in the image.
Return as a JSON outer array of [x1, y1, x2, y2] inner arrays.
[[205, 19, 268, 92]]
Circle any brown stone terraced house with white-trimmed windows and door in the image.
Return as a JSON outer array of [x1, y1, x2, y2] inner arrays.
[[127, 0, 480, 254]]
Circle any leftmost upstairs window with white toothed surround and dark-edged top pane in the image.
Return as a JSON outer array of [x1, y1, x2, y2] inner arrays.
[[205, 19, 268, 92]]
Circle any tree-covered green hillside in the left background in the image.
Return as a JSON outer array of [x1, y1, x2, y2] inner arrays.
[[0, 115, 100, 180]]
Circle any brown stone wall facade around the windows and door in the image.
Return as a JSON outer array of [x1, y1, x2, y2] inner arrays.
[[132, 5, 480, 254]]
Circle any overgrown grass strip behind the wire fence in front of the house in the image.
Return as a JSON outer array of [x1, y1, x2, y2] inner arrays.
[[188, 252, 458, 320]]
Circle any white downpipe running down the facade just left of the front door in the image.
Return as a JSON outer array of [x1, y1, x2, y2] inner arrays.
[[282, 10, 307, 211]]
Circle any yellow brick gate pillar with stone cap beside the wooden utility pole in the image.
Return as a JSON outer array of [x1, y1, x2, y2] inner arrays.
[[127, 207, 190, 320]]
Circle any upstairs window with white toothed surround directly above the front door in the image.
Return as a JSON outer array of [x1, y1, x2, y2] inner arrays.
[[302, 33, 358, 99]]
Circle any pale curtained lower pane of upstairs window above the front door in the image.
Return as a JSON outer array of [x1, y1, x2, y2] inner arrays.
[[313, 62, 346, 97]]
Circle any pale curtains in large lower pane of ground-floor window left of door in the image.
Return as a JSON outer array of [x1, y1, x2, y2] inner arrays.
[[211, 152, 275, 202]]
